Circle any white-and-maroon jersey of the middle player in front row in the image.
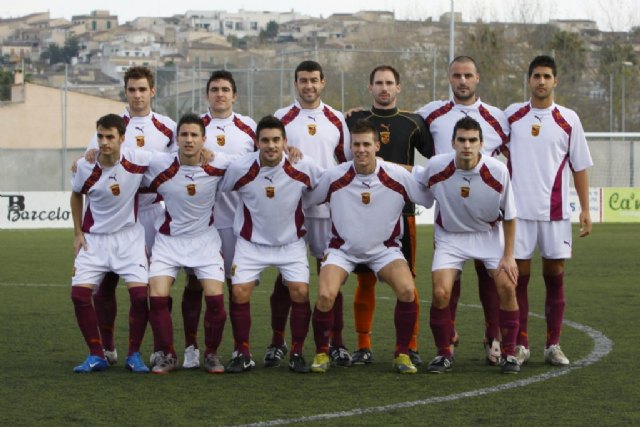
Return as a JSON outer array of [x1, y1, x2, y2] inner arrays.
[[221, 152, 322, 246]]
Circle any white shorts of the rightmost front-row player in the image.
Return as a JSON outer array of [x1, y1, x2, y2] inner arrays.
[[431, 223, 504, 271]]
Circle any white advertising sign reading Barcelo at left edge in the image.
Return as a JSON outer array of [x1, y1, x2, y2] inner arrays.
[[0, 191, 73, 229]]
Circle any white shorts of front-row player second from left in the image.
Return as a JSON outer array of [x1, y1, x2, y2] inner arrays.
[[149, 227, 224, 282]]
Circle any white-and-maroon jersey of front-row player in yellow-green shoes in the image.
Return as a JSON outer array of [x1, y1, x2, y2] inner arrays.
[[305, 160, 433, 257]]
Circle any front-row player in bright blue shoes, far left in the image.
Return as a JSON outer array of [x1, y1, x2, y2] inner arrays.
[[70, 114, 151, 373]]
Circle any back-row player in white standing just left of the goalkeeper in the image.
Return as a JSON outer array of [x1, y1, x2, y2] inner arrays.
[[264, 61, 351, 367]]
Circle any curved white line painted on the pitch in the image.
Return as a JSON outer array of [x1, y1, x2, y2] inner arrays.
[[228, 305, 613, 427]]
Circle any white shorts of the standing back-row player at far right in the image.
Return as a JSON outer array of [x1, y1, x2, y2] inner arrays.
[[514, 218, 571, 259]]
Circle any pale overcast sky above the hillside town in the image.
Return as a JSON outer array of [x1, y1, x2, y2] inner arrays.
[[0, 0, 640, 31]]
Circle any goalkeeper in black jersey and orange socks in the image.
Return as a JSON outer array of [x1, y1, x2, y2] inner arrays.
[[347, 65, 433, 366]]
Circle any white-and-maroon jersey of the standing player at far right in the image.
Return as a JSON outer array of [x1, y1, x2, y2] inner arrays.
[[505, 102, 593, 221]]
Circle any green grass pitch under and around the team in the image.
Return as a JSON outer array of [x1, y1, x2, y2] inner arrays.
[[0, 224, 640, 426]]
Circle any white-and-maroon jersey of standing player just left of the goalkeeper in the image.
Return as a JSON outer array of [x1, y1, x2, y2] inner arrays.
[[274, 101, 352, 218]]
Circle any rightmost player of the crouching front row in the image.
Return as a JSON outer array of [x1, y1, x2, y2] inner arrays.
[[414, 117, 520, 373]]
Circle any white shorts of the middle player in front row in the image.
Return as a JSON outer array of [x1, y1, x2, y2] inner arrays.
[[231, 237, 309, 285]]
